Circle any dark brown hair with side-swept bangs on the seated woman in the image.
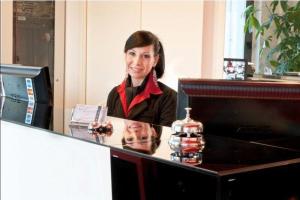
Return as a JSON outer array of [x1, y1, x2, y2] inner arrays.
[[124, 30, 165, 78]]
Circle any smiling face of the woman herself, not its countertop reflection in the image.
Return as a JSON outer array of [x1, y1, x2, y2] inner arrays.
[[125, 45, 159, 80]]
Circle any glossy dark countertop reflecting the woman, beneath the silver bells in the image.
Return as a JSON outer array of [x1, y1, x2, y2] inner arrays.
[[1, 94, 300, 176]]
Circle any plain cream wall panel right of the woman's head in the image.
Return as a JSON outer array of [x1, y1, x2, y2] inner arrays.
[[142, 1, 203, 90]]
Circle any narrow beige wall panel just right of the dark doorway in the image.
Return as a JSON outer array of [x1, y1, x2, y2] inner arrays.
[[64, 1, 87, 131]]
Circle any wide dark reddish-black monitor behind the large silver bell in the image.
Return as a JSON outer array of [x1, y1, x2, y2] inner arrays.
[[177, 79, 300, 139]]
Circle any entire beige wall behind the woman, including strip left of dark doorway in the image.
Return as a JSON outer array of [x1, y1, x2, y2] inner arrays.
[[1, 0, 225, 133]]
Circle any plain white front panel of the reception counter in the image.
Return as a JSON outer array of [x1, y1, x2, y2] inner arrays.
[[1, 120, 112, 200]]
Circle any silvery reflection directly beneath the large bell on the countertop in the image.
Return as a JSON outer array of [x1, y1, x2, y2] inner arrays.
[[171, 152, 202, 165]]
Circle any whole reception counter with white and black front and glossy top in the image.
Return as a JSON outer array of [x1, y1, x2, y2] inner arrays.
[[1, 117, 300, 200]]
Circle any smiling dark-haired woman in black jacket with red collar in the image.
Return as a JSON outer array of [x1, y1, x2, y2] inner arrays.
[[107, 31, 177, 126]]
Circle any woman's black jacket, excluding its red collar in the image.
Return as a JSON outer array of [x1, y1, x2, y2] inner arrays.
[[107, 82, 177, 126]]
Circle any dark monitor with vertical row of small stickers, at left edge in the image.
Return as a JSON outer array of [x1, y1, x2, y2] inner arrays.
[[0, 64, 53, 105]]
